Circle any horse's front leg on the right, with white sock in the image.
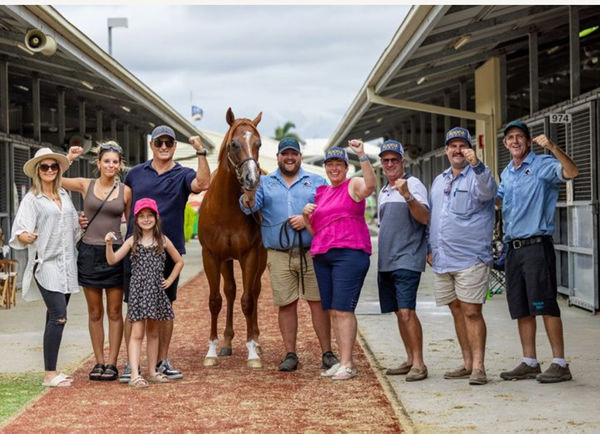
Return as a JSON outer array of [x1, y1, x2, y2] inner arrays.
[[240, 249, 264, 368]]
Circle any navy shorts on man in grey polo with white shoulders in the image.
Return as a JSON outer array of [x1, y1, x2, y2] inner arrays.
[[377, 269, 421, 313]]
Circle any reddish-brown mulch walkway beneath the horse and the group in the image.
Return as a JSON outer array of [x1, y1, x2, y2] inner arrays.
[[2, 269, 402, 433]]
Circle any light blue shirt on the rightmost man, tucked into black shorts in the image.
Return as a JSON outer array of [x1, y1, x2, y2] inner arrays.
[[498, 152, 565, 242]]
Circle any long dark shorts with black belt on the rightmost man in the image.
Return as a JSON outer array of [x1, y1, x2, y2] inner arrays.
[[504, 237, 560, 319]]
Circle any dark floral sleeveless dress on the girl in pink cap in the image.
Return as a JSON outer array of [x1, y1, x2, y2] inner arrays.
[[128, 243, 175, 322]]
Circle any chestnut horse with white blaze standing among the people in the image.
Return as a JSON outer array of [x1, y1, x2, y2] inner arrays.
[[198, 108, 267, 368]]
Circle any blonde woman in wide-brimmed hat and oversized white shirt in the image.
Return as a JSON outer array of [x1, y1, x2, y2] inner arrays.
[[9, 148, 81, 387]]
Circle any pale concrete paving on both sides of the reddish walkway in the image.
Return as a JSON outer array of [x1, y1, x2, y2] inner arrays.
[[0, 238, 600, 433]]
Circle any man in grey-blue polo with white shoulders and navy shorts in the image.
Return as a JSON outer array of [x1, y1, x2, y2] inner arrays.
[[377, 140, 429, 381]]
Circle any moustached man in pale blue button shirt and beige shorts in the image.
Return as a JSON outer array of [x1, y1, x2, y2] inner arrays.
[[428, 127, 497, 385]]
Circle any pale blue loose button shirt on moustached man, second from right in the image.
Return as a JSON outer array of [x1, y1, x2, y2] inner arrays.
[[429, 162, 497, 274]]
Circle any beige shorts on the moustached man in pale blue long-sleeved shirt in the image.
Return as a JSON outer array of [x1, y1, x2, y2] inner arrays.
[[433, 262, 490, 306]]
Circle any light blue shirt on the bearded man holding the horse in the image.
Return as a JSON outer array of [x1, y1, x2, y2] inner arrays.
[[240, 168, 327, 250]]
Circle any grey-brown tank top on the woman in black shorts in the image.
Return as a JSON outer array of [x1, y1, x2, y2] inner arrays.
[[83, 180, 125, 245]]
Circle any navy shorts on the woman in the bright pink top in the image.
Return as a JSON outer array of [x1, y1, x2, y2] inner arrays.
[[313, 249, 371, 312]]
